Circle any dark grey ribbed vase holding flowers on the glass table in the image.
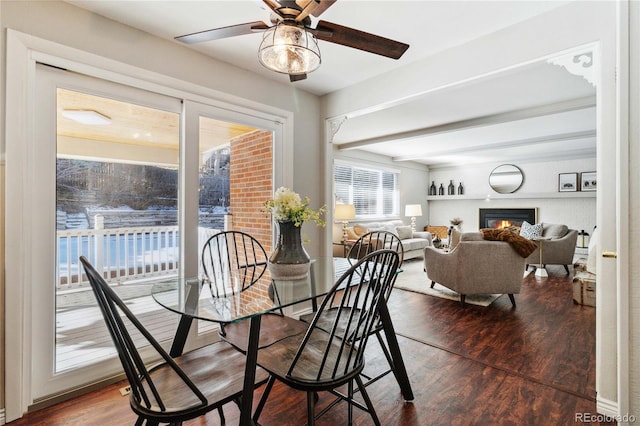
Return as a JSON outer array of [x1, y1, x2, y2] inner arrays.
[[268, 222, 311, 280]]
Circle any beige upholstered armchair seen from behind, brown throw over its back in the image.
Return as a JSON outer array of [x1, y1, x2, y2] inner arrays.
[[424, 232, 525, 307]]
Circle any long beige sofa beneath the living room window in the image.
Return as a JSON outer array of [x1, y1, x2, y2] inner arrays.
[[340, 220, 432, 260]]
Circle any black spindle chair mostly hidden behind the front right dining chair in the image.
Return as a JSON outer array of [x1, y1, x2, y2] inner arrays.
[[300, 231, 404, 386]]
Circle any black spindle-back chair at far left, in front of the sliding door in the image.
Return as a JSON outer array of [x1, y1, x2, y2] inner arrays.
[[80, 256, 267, 425]]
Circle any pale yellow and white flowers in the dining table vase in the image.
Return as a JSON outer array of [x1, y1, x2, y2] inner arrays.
[[263, 187, 327, 226]]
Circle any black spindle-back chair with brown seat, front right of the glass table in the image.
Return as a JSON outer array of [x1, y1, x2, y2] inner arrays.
[[254, 250, 399, 425]]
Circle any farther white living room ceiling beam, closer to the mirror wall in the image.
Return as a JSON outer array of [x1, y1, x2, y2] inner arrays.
[[392, 129, 596, 161]]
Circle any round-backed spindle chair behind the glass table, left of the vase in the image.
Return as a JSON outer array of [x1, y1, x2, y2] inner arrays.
[[201, 231, 306, 353]]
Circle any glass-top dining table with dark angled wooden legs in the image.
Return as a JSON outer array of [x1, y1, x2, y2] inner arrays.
[[152, 257, 414, 425]]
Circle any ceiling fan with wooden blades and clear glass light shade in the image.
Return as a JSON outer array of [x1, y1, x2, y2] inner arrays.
[[175, 0, 409, 82]]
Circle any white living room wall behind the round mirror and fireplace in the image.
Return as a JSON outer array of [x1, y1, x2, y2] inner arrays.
[[429, 158, 596, 233]]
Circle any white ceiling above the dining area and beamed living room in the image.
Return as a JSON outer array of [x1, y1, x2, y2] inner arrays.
[[68, 0, 595, 167]]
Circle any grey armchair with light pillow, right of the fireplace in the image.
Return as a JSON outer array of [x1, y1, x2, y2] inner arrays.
[[527, 223, 578, 274]]
